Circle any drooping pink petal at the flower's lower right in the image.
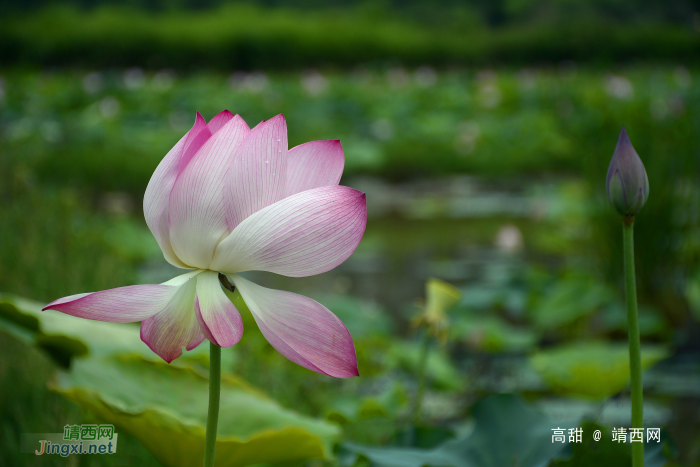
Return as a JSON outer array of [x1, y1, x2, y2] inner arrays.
[[231, 275, 359, 378]]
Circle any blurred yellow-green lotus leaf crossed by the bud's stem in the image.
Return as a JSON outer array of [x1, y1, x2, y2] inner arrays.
[[530, 342, 669, 398]]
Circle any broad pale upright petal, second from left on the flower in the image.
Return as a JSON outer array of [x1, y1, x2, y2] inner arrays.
[[170, 115, 250, 269]]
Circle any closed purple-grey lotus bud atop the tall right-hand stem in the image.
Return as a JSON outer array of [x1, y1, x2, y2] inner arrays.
[[605, 126, 649, 218]]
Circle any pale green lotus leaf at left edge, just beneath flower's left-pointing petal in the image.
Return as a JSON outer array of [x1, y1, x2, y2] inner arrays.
[[0, 294, 232, 368]]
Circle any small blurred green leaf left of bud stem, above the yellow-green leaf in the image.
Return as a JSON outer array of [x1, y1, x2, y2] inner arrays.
[[532, 276, 615, 329]]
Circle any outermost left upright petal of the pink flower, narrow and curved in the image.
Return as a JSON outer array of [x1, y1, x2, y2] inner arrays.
[[143, 112, 211, 268]]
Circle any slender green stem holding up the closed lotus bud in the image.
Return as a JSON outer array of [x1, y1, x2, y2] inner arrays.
[[622, 217, 644, 467]]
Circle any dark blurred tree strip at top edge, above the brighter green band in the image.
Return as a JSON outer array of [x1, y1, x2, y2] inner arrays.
[[0, 0, 700, 26]]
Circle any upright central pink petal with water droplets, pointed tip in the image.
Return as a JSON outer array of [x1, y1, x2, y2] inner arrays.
[[225, 114, 287, 231]]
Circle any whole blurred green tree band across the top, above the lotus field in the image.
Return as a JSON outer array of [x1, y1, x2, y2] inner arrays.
[[0, 0, 700, 70]]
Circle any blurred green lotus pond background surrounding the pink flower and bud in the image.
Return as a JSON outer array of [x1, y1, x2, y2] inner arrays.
[[0, 0, 700, 467]]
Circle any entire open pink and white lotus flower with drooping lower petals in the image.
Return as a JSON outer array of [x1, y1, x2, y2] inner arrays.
[[44, 111, 367, 377]]
